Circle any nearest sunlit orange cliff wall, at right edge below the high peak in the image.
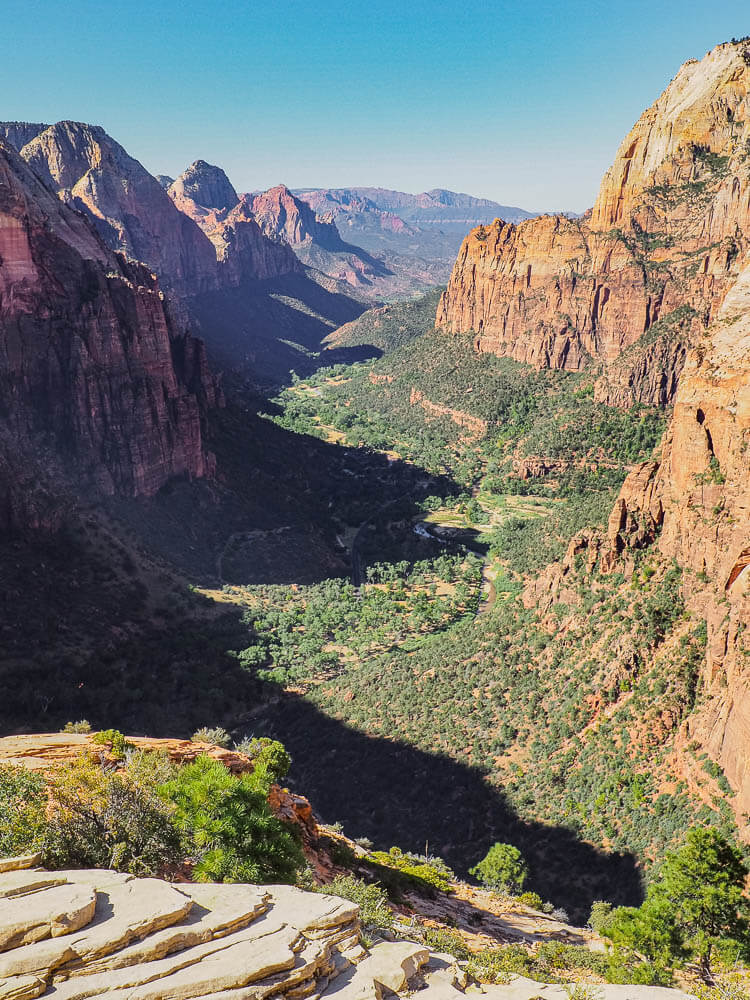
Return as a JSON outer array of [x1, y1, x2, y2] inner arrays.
[[609, 256, 750, 834]]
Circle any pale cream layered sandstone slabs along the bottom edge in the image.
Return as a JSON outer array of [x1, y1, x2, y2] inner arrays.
[[0, 858, 696, 1000]]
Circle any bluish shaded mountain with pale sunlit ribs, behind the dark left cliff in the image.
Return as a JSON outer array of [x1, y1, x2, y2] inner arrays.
[[0, 122, 217, 294]]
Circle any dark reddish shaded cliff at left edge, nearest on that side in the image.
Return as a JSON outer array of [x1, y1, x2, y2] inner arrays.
[[0, 133, 216, 512]]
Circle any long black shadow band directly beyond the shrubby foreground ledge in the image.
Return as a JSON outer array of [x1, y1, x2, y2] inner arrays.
[[246, 693, 643, 920]]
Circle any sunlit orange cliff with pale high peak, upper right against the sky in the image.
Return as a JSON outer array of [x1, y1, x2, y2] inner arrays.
[[436, 43, 750, 405]]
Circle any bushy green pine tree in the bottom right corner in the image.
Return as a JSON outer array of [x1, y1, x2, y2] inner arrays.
[[602, 827, 750, 982]]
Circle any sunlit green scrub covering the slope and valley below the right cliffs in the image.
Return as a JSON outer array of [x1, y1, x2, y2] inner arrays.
[[235, 310, 733, 916]]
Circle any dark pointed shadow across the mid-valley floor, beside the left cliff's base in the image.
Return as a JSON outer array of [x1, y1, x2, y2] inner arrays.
[[106, 392, 458, 587]]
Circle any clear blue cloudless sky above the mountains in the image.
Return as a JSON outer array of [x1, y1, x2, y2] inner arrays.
[[0, 0, 750, 211]]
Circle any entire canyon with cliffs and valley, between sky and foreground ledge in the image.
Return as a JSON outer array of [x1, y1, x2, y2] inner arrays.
[[0, 31, 750, 940]]
